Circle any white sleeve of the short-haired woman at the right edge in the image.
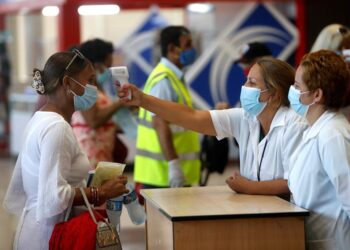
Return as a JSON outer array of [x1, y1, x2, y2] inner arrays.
[[320, 134, 350, 218]]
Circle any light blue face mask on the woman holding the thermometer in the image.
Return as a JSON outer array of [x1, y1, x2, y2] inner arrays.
[[240, 86, 268, 116]]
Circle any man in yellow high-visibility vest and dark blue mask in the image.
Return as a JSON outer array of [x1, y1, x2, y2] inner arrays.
[[134, 26, 200, 201]]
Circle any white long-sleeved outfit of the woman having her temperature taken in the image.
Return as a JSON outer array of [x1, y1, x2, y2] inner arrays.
[[4, 111, 90, 250]]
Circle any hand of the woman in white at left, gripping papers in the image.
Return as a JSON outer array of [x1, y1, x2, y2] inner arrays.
[[99, 175, 129, 200]]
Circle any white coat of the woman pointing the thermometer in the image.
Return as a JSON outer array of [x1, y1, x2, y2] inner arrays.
[[210, 107, 307, 181]]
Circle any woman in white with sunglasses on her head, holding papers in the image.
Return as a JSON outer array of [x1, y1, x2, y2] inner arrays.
[[4, 50, 128, 250]]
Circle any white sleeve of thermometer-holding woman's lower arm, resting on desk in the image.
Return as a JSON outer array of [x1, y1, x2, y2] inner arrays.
[[281, 120, 307, 179]]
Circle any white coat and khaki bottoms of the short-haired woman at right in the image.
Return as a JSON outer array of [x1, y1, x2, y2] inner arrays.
[[288, 111, 350, 250]]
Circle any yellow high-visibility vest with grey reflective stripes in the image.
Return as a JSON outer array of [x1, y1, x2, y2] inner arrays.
[[134, 63, 200, 187]]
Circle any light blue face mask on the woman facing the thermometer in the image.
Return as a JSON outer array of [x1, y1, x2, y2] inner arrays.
[[69, 77, 97, 110]]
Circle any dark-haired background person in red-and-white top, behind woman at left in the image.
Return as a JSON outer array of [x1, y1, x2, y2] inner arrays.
[[71, 39, 127, 169]]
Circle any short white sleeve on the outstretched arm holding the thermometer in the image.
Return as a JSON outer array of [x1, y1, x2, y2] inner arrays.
[[210, 108, 243, 140]]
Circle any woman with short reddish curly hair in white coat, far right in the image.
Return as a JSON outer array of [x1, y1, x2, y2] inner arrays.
[[288, 50, 350, 250]]
